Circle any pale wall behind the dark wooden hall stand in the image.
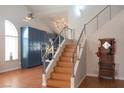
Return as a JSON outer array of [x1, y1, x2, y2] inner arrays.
[[86, 6, 124, 79]]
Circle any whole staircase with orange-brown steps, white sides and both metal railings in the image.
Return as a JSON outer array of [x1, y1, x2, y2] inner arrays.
[[42, 5, 124, 88]]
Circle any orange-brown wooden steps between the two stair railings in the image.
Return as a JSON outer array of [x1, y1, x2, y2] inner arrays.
[[47, 43, 76, 88]]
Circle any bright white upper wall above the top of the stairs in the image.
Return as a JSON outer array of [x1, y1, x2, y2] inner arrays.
[[68, 5, 105, 40]]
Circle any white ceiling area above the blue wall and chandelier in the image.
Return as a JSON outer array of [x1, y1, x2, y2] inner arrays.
[[26, 5, 69, 32]]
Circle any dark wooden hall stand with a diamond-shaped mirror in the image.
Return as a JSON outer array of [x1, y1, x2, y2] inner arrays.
[[97, 38, 115, 79]]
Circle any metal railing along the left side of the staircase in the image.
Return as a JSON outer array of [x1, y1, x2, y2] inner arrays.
[[42, 26, 73, 74]]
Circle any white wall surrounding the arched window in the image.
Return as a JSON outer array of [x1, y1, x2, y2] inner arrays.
[[0, 5, 50, 72]]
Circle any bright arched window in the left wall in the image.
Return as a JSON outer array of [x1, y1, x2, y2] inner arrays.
[[5, 20, 18, 61]]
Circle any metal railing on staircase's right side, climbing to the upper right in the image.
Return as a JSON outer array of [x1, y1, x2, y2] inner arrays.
[[72, 5, 111, 77]]
